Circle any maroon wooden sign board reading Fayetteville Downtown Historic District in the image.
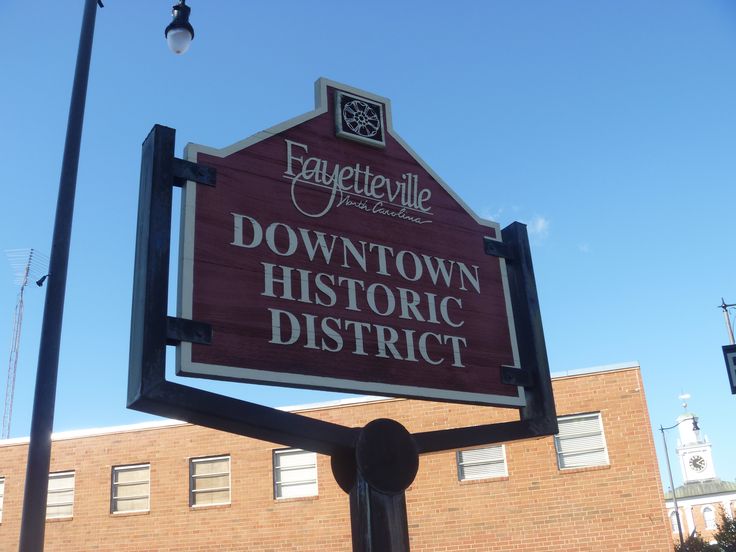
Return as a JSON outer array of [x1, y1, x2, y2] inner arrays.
[[177, 79, 525, 407]]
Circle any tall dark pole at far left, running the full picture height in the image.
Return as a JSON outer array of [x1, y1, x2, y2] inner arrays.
[[19, 0, 97, 552]]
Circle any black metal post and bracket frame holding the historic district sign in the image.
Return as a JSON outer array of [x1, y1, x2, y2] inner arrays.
[[128, 125, 557, 552]]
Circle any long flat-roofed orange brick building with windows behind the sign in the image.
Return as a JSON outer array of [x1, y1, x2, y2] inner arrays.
[[0, 364, 672, 552]]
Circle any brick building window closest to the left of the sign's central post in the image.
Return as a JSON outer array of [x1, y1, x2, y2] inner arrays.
[[273, 449, 317, 498]]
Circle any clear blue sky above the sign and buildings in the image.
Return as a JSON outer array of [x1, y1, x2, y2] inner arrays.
[[0, 0, 736, 492]]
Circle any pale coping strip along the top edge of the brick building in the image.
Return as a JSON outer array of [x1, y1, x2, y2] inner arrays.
[[0, 361, 639, 447]]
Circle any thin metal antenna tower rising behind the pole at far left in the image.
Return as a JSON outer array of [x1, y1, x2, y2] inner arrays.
[[0, 249, 48, 439]]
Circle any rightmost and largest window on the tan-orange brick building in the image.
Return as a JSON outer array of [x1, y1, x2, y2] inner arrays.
[[555, 412, 609, 470]]
